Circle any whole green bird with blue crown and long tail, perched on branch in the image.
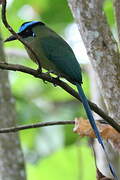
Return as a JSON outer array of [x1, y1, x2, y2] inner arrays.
[[5, 21, 117, 180]]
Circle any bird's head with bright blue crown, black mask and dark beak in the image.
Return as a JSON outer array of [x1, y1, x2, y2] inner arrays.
[[4, 21, 45, 42]]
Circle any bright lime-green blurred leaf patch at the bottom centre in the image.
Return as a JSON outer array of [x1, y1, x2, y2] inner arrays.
[[27, 144, 95, 180]]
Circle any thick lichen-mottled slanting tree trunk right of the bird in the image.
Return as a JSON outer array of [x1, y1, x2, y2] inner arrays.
[[68, 0, 120, 179]]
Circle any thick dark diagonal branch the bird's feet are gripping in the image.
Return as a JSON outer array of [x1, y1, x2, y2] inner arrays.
[[0, 63, 120, 132]]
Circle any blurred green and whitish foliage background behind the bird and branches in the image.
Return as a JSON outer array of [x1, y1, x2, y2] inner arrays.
[[1, 0, 115, 180]]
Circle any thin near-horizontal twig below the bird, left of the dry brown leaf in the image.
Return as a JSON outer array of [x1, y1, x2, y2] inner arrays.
[[0, 121, 75, 133]]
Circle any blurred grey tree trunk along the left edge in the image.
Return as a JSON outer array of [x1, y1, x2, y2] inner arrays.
[[0, 33, 26, 180]]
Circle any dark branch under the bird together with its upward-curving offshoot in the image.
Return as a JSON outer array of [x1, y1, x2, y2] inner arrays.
[[0, 0, 120, 132]]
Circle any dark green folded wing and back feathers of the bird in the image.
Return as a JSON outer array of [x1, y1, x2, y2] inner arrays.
[[41, 34, 82, 83]]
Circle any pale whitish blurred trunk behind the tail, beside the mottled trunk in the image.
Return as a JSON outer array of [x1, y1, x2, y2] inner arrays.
[[88, 66, 120, 180]]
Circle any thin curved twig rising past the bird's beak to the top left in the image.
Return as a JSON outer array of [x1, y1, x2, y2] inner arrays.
[[2, 0, 42, 70]]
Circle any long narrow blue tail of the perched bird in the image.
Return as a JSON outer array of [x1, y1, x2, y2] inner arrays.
[[76, 83, 118, 180]]
